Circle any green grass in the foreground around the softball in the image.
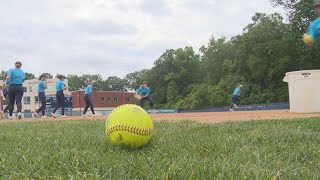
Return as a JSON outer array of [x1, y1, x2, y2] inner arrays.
[[0, 118, 320, 179]]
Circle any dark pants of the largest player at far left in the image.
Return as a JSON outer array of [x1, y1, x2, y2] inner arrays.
[[9, 84, 24, 116]]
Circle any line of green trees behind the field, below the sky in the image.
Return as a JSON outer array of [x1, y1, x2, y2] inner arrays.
[[3, 0, 320, 109]]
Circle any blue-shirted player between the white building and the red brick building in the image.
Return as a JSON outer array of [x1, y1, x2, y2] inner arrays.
[[51, 75, 68, 118]]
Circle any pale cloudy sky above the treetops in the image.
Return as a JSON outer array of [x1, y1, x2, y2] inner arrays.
[[0, 0, 282, 77]]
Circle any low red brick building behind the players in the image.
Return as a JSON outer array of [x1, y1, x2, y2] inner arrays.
[[71, 91, 135, 111]]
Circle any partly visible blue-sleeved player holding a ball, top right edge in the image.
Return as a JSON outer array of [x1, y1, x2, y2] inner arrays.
[[303, 0, 320, 46]]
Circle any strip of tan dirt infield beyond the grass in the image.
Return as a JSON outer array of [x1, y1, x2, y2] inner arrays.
[[0, 110, 320, 123]]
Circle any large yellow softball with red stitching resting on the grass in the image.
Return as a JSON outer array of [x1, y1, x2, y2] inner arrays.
[[106, 104, 154, 148]]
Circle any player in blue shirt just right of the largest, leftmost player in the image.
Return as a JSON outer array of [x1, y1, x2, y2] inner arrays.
[[34, 74, 48, 119]]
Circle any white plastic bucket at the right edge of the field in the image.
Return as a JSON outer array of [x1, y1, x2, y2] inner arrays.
[[283, 70, 320, 113]]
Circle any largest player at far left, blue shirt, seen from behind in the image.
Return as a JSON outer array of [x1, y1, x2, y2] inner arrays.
[[6, 61, 25, 119]]
